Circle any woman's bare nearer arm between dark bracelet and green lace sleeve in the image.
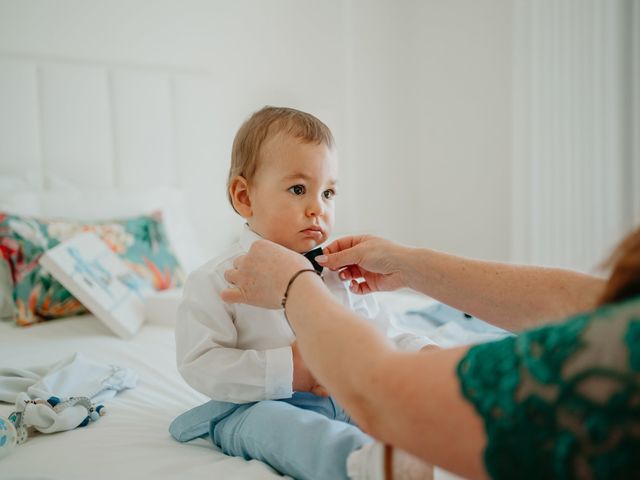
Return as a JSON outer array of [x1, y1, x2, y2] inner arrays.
[[286, 275, 484, 477]]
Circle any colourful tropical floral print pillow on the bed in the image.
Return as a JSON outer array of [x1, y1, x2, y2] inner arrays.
[[0, 212, 184, 326]]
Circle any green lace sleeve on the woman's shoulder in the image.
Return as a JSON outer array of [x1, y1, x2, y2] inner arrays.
[[457, 298, 640, 479]]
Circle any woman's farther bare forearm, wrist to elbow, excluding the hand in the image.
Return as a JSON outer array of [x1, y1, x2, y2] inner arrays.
[[397, 248, 605, 330]]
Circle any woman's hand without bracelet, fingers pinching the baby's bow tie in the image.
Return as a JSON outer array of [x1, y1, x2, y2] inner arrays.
[[316, 235, 408, 294]]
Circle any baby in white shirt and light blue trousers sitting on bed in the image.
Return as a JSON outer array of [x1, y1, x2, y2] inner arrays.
[[170, 107, 432, 480]]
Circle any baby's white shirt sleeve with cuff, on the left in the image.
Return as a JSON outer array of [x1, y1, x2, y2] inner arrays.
[[176, 267, 293, 403]]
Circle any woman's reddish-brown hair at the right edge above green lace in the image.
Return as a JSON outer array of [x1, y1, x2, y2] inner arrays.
[[598, 228, 640, 305]]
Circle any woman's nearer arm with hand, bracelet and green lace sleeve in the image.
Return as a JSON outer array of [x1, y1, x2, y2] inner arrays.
[[221, 241, 640, 478]]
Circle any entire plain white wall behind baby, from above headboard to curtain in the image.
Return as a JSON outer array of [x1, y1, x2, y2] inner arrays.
[[0, 0, 511, 259]]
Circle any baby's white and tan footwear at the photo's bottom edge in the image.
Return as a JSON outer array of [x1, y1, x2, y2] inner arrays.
[[347, 442, 433, 480]]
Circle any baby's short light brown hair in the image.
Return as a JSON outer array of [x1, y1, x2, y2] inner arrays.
[[227, 106, 334, 206]]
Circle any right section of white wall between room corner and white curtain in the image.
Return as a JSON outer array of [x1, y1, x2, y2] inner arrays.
[[350, 0, 512, 260]]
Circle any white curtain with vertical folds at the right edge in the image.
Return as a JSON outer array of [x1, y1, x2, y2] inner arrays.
[[512, 0, 640, 271]]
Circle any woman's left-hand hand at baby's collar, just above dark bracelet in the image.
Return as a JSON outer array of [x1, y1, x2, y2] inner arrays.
[[220, 240, 312, 310]]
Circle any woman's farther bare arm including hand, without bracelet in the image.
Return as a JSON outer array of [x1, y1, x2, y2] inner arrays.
[[316, 236, 605, 330]]
